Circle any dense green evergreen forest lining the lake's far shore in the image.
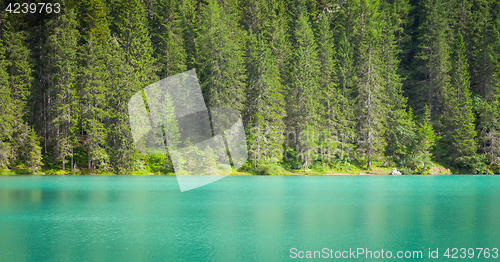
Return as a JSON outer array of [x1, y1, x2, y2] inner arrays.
[[0, 0, 500, 174]]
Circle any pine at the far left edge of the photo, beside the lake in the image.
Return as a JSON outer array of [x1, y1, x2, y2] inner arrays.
[[0, 22, 41, 172]]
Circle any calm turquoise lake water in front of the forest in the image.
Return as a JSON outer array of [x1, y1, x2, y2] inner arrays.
[[0, 176, 500, 261]]
